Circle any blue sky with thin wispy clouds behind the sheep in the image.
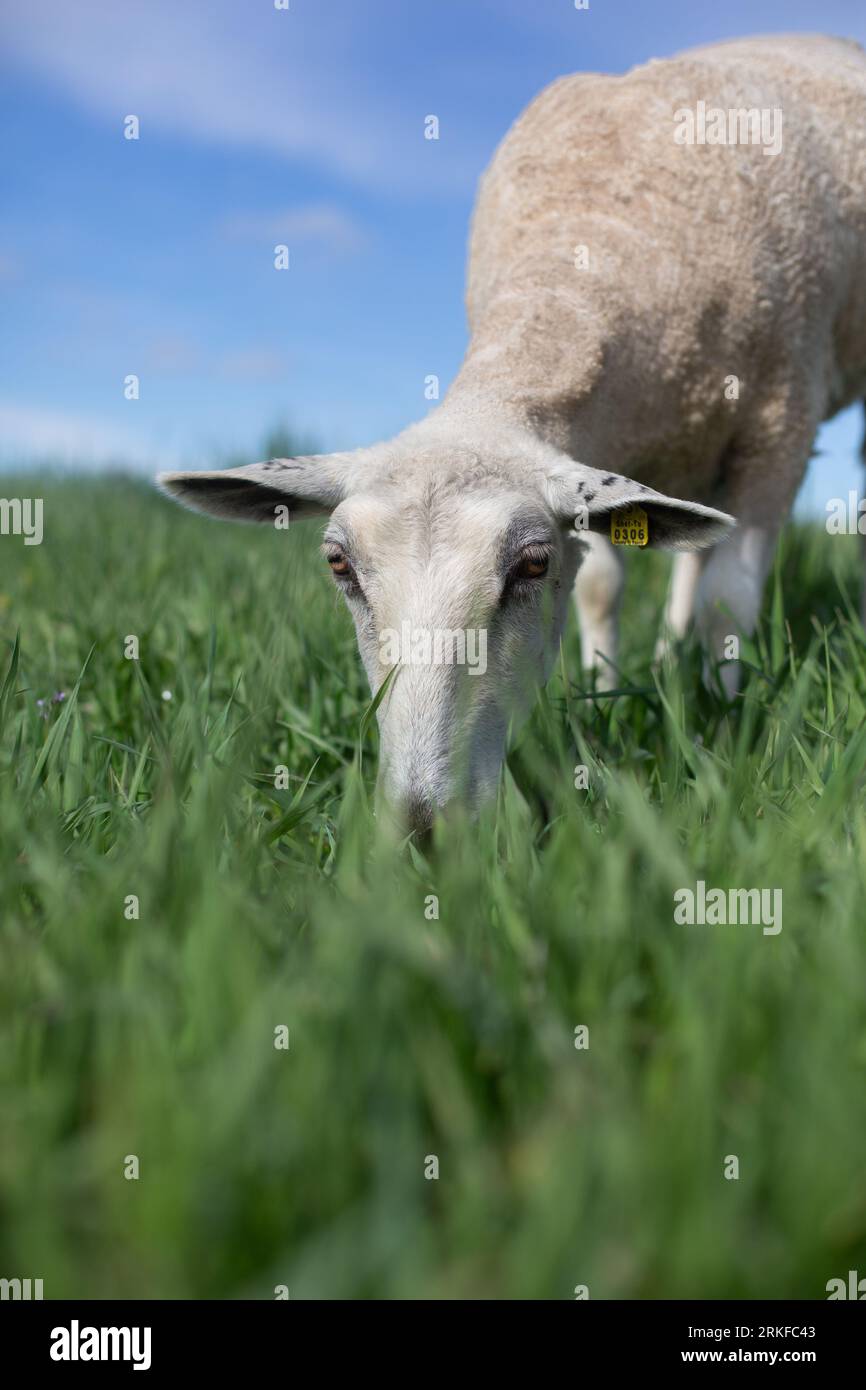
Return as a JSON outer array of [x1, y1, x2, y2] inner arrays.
[[0, 0, 866, 510]]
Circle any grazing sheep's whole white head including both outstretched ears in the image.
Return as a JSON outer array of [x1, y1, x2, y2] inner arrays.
[[160, 446, 730, 830]]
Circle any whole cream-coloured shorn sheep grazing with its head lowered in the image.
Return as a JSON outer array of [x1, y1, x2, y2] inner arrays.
[[160, 36, 866, 830]]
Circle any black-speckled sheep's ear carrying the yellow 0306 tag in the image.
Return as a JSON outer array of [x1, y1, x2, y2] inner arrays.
[[546, 463, 737, 550]]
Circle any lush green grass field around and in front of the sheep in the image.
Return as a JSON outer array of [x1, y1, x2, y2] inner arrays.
[[0, 477, 866, 1298]]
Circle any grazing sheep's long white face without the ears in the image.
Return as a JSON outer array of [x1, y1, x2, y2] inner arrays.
[[322, 474, 580, 828]]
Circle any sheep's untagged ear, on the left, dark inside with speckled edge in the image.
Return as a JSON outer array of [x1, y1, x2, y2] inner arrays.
[[157, 453, 357, 523]]
